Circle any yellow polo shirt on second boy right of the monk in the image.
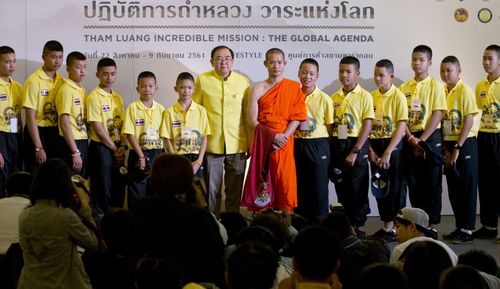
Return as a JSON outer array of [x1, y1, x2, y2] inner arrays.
[[332, 84, 375, 137]]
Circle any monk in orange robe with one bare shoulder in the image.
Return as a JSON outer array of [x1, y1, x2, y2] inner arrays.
[[242, 48, 307, 212]]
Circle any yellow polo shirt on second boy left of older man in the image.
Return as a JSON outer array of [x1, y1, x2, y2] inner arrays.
[[122, 99, 165, 150]]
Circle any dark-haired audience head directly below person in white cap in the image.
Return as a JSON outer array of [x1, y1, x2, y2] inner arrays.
[[399, 241, 453, 289]]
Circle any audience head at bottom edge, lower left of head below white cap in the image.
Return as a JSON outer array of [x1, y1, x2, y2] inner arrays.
[[355, 263, 408, 289]]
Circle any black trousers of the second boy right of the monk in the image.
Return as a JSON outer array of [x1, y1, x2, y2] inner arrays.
[[330, 137, 370, 227]]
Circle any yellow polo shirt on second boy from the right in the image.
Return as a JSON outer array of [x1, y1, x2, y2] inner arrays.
[[442, 79, 479, 141]]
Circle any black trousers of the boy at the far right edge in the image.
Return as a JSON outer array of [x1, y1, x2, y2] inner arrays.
[[477, 132, 500, 228]]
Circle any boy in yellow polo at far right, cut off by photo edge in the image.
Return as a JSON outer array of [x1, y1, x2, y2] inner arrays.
[[474, 44, 500, 242]]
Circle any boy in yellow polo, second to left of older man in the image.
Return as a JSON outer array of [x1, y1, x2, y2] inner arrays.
[[122, 71, 165, 197]]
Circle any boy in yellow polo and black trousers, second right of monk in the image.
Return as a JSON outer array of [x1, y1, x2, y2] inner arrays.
[[330, 56, 375, 239]]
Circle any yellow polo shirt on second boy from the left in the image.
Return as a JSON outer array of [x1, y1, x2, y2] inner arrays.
[[23, 67, 64, 127]]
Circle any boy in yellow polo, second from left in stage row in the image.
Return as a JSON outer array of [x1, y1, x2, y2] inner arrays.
[[23, 40, 64, 172]]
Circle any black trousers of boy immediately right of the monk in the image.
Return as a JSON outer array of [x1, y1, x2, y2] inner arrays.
[[294, 138, 330, 224]]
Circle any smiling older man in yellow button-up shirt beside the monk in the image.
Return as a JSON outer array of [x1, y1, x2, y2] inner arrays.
[[193, 46, 250, 214]]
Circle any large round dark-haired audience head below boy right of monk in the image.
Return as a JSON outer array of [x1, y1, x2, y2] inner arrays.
[[292, 226, 340, 280]]
